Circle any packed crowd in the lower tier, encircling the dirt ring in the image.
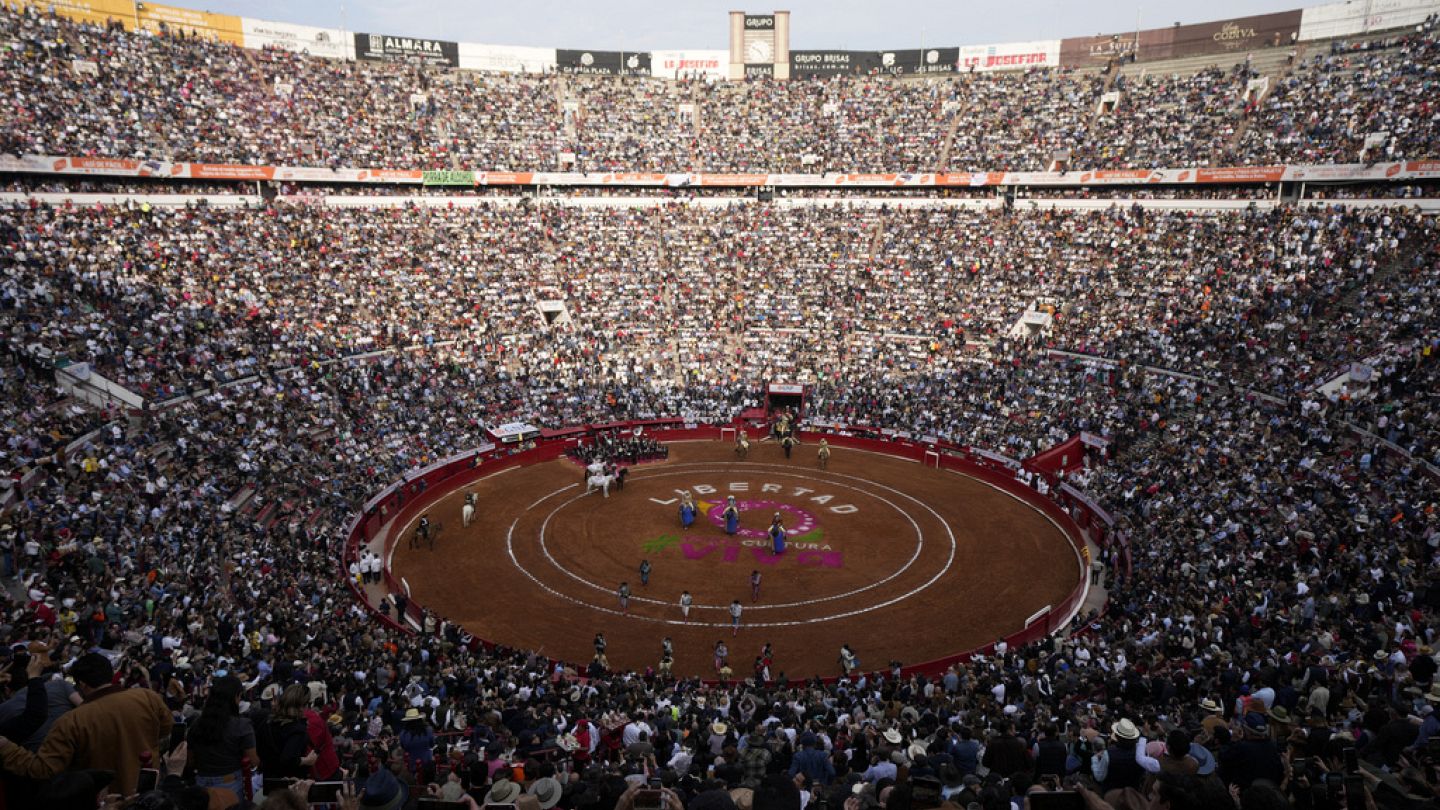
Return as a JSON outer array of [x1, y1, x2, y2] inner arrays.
[[0, 184, 1440, 809]]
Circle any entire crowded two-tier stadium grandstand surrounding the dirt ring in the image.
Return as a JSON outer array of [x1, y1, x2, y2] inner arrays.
[[0, 0, 1440, 810]]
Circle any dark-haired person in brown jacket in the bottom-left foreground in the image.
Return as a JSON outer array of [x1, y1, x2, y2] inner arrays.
[[0, 653, 174, 796]]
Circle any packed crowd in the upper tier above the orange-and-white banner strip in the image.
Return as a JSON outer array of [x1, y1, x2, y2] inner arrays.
[[0, 6, 1440, 173]]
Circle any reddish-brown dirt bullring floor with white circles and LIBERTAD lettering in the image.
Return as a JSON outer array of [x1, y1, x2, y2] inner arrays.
[[354, 428, 1089, 679]]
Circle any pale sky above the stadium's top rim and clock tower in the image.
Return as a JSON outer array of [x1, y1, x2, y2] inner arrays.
[[194, 0, 1318, 50]]
